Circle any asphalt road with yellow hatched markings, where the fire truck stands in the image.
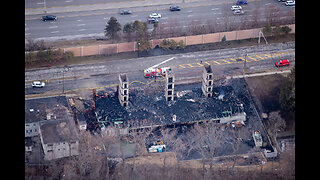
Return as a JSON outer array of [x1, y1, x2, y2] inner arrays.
[[25, 42, 295, 97]]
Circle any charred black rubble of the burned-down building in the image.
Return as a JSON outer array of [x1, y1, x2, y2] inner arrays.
[[95, 79, 246, 135]]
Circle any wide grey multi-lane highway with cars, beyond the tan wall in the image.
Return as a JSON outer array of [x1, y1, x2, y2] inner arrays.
[[25, 0, 294, 41]]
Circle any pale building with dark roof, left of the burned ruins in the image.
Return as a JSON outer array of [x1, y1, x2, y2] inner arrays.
[[25, 96, 79, 160]]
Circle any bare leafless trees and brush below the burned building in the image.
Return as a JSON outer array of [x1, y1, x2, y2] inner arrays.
[[26, 123, 295, 180]]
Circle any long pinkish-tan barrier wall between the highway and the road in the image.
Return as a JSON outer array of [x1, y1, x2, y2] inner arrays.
[[28, 24, 295, 57]]
